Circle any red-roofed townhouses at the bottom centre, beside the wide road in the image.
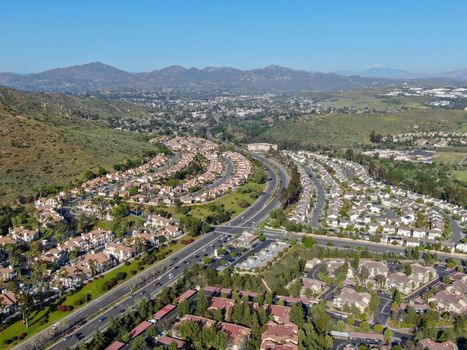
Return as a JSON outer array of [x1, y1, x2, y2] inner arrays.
[[107, 286, 308, 350]]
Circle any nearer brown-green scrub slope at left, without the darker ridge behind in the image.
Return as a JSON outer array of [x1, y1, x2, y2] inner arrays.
[[0, 114, 157, 202]]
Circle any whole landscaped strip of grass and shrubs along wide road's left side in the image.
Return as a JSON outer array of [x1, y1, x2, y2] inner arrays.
[[0, 235, 196, 349]]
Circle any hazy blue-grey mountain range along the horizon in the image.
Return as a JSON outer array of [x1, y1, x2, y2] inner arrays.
[[0, 62, 467, 93]]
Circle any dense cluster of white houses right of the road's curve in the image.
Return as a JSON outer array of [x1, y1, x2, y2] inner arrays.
[[288, 152, 467, 252]]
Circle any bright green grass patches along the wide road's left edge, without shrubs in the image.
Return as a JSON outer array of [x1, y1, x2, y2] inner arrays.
[[0, 236, 196, 349]]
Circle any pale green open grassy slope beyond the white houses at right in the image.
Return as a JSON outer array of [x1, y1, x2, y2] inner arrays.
[[255, 109, 467, 146]]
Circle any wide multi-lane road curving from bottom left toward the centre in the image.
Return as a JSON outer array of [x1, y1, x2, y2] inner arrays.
[[14, 155, 289, 350]]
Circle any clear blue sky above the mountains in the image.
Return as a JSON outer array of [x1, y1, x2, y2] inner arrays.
[[0, 0, 467, 73]]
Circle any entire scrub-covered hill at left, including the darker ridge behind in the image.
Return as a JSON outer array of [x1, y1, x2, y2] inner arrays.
[[0, 88, 156, 204]]
